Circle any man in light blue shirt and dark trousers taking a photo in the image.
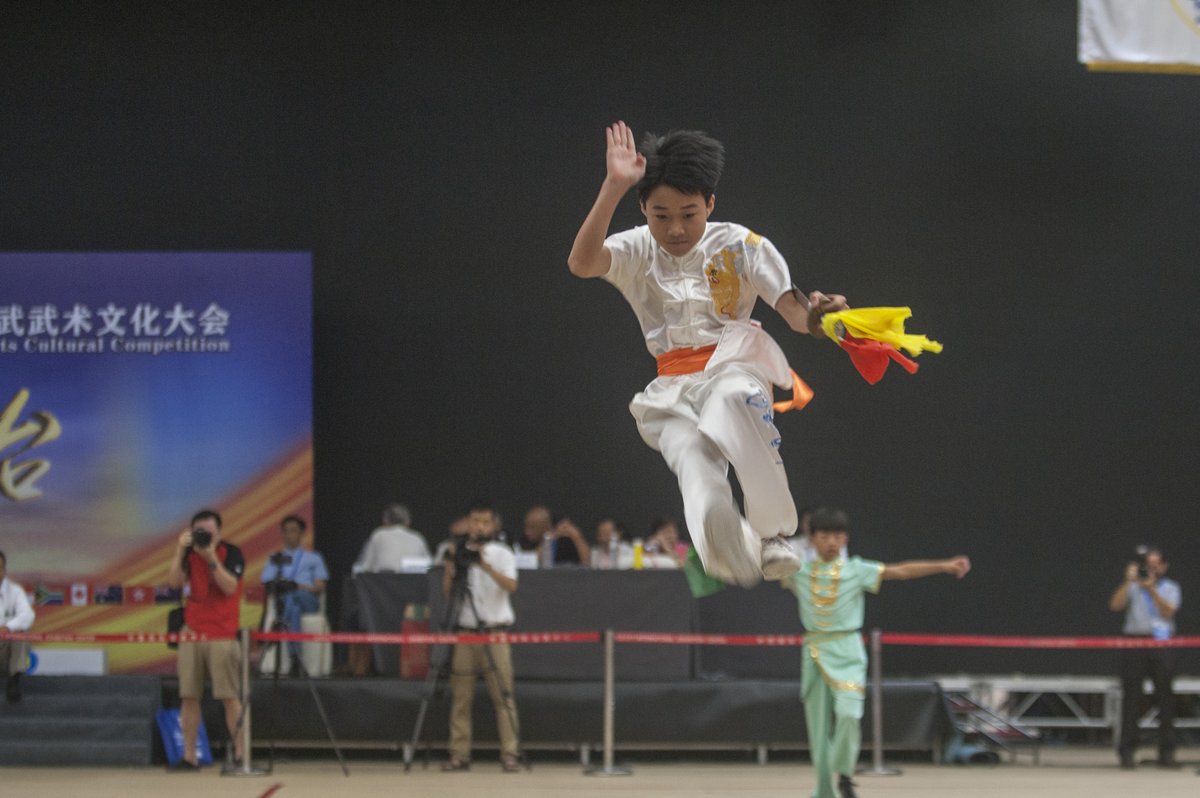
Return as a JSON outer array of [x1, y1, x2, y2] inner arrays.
[[1109, 546, 1182, 769]]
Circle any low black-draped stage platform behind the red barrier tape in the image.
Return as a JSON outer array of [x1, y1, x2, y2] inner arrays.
[[163, 677, 952, 756]]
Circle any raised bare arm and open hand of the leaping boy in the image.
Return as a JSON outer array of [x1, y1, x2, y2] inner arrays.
[[566, 122, 646, 277]]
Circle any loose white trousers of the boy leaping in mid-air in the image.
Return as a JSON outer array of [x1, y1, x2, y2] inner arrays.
[[632, 364, 797, 586]]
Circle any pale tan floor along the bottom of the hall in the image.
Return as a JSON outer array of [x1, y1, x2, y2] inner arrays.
[[0, 748, 1200, 798]]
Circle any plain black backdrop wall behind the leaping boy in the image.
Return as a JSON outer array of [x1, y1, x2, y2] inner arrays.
[[0, 0, 1200, 670]]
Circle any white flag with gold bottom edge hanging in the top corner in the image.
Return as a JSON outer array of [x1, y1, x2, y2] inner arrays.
[[1079, 0, 1200, 74]]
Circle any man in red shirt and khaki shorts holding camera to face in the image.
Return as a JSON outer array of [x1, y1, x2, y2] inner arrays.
[[167, 510, 246, 770]]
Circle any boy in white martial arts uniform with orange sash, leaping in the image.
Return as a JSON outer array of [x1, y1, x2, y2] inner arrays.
[[568, 122, 846, 587]]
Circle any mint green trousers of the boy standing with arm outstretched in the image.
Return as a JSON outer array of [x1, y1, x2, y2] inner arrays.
[[803, 638, 866, 798]]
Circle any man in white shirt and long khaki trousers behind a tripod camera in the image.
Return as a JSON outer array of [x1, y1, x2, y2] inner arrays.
[[442, 503, 521, 773]]
